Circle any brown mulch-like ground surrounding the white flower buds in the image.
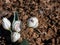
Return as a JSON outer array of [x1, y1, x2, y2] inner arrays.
[[0, 0, 60, 45]]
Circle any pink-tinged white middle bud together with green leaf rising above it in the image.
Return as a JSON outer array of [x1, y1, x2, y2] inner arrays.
[[12, 12, 21, 32]]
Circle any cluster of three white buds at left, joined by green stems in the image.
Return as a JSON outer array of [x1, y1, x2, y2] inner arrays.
[[2, 13, 21, 42]]
